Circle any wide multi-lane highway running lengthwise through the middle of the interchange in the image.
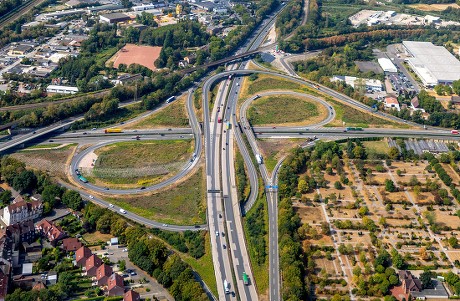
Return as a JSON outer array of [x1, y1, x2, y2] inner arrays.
[[202, 4, 284, 301]]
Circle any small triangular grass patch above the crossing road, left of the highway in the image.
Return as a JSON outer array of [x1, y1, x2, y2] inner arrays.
[[125, 97, 189, 129]]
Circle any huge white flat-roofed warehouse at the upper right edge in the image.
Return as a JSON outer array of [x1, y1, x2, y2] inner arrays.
[[403, 41, 460, 87]]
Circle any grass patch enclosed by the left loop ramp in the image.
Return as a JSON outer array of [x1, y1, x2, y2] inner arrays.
[[90, 140, 193, 188]]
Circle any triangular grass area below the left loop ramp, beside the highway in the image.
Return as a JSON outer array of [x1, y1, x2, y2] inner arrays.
[[108, 169, 206, 225]]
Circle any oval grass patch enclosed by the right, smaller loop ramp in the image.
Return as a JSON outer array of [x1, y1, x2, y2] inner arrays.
[[248, 95, 320, 125]]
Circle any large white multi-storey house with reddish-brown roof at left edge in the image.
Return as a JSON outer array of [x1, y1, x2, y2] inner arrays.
[[2, 195, 43, 226]]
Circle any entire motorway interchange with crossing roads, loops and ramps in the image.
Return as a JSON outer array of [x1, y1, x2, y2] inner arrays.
[[0, 5, 458, 300]]
